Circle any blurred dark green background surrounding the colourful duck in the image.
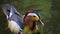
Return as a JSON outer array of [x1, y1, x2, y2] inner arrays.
[[0, 0, 60, 34]]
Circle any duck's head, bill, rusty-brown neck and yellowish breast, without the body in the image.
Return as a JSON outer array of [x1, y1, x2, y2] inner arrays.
[[23, 10, 44, 34]]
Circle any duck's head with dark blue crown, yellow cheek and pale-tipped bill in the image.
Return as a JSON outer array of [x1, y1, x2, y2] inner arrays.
[[25, 10, 44, 25]]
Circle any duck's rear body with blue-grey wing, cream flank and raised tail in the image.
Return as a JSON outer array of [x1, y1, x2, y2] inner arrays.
[[2, 4, 24, 34]]
